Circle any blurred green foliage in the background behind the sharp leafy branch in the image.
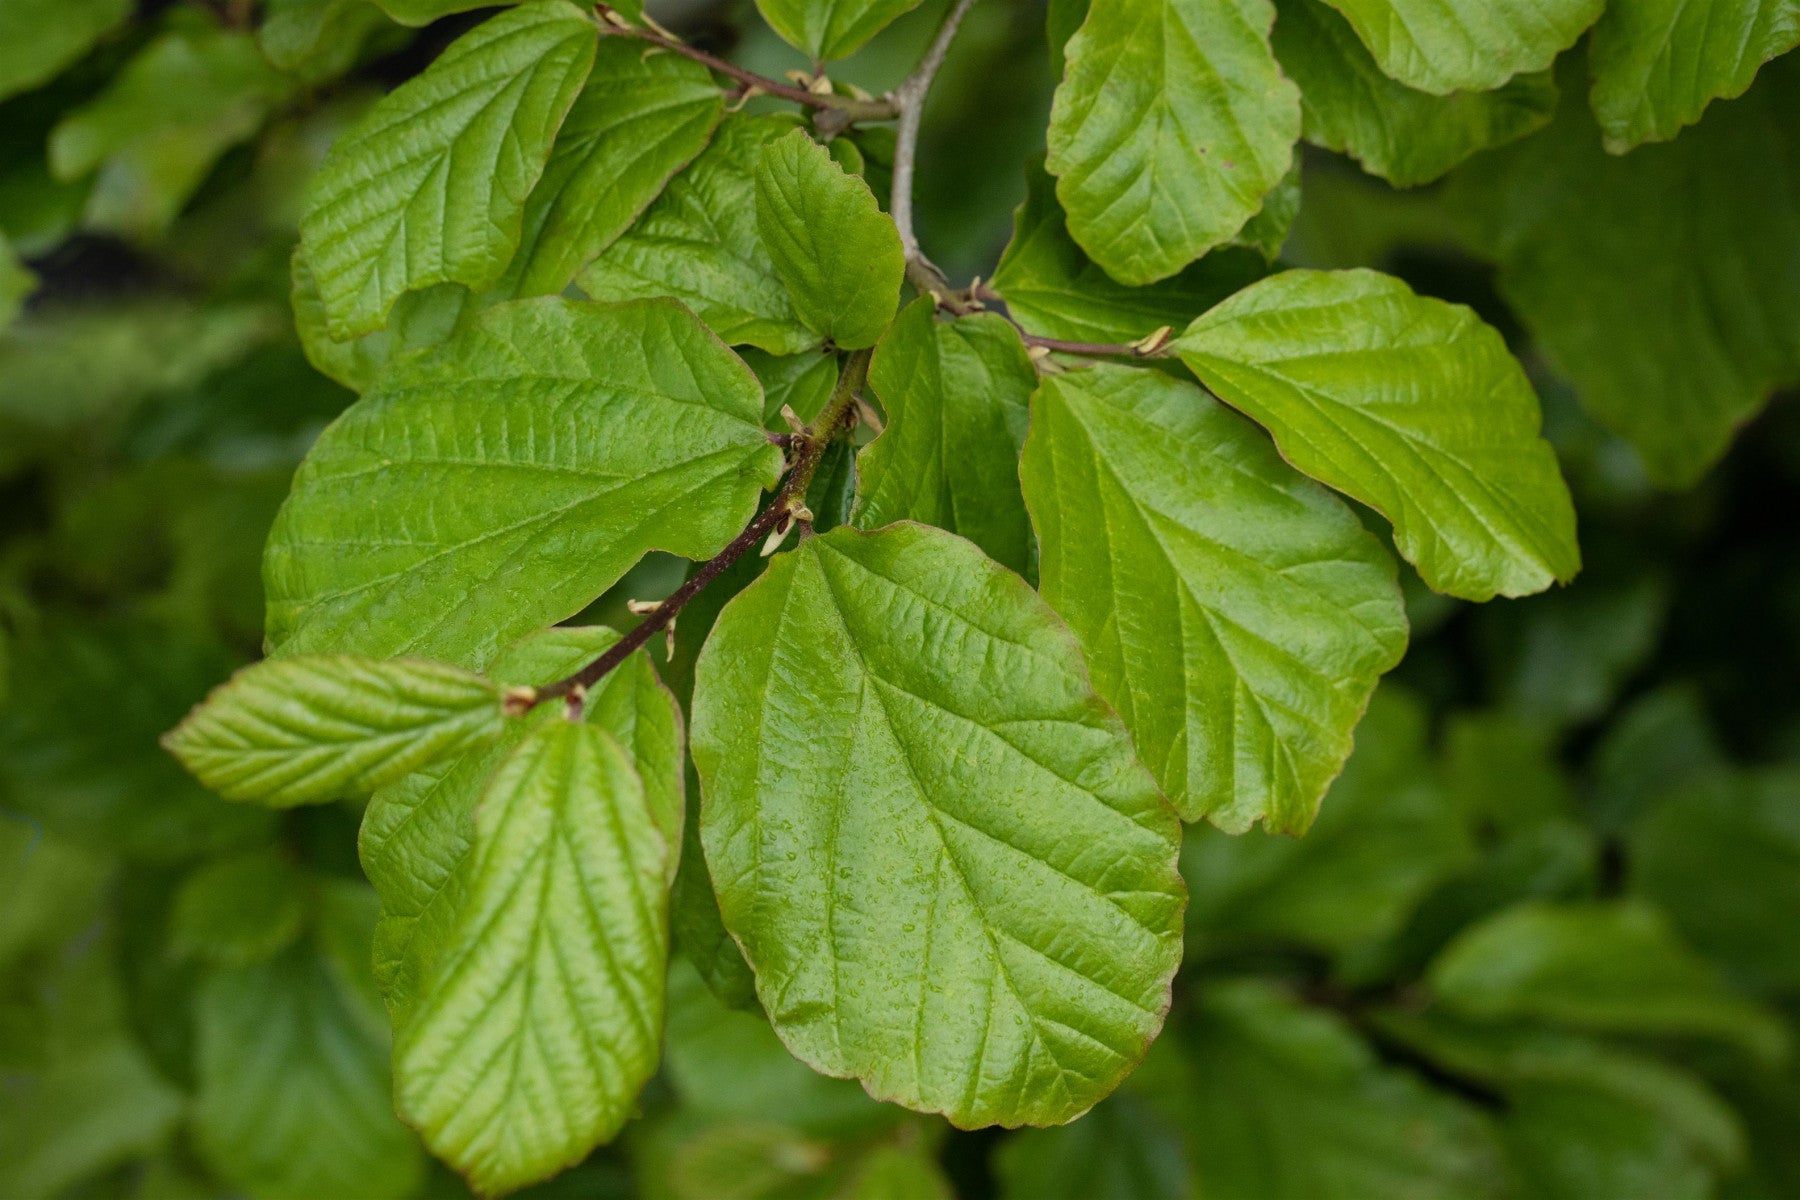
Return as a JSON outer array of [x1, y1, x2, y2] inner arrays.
[[0, 0, 1800, 1200]]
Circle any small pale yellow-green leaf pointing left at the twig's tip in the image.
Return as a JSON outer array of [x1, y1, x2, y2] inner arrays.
[[162, 655, 504, 808]]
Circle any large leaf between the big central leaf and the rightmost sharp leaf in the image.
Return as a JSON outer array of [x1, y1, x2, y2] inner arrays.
[[1022, 365, 1406, 833]]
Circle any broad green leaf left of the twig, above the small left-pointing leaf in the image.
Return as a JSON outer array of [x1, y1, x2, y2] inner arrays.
[[263, 297, 781, 666]]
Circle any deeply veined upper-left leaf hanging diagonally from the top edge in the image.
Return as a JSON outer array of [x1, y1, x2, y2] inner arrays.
[[301, 0, 596, 342]]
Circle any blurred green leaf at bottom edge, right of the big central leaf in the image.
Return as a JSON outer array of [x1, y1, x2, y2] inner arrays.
[[1130, 981, 1510, 1200]]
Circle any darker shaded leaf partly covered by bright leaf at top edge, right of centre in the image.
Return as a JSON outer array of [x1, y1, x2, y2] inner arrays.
[[1273, 0, 1557, 187]]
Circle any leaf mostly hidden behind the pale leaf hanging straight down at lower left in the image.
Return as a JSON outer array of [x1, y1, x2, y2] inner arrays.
[[358, 626, 684, 1027]]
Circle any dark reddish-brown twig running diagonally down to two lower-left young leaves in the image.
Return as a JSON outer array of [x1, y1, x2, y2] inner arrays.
[[522, 351, 869, 714]]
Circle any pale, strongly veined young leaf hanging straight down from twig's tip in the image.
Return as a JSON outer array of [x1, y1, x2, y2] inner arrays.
[[394, 720, 671, 1195]]
